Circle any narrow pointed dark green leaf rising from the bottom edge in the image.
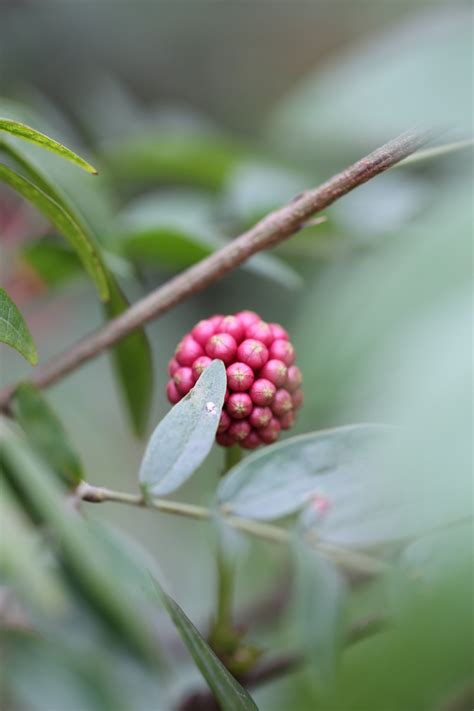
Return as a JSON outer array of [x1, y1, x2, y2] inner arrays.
[[154, 580, 258, 711]]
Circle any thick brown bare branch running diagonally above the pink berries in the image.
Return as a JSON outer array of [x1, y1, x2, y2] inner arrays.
[[0, 131, 428, 408]]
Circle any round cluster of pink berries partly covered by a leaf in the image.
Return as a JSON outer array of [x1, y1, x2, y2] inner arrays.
[[166, 311, 303, 449]]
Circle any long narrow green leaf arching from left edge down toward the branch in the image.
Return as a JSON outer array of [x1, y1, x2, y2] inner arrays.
[[0, 163, 109, 299]]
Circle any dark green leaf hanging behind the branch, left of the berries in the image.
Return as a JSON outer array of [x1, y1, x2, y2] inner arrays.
[[104, 279, 153, 436]]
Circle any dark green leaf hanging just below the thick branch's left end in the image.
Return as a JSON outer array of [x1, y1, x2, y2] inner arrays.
[[11, 383, 83, 486]]
